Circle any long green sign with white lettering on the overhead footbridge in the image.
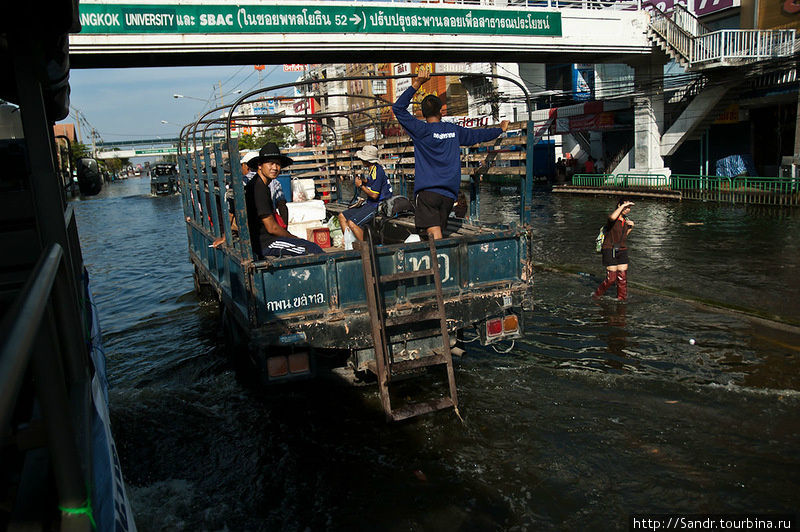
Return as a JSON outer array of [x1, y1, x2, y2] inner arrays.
[[80, 3, 561, 37]]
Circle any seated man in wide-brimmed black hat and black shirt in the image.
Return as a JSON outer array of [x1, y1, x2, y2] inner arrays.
[[244, 142, 323, 258]]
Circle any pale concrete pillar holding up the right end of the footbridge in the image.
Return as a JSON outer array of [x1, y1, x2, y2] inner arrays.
[[632, 56, 669, 175]]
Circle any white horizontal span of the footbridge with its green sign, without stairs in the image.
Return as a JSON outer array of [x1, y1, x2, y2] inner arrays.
[[70, 0, 653, 68]]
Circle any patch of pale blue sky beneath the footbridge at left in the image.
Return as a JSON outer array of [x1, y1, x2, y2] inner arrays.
[[61, 65, 300, 143]]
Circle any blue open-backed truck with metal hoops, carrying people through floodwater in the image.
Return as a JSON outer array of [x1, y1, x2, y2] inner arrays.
[[178, 71, 535, 420]]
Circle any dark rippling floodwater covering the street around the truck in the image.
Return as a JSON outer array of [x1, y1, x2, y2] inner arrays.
[[75, 179, 800, 531]]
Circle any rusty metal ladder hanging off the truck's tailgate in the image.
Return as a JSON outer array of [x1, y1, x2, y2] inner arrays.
[[356, 231, 461, 421]]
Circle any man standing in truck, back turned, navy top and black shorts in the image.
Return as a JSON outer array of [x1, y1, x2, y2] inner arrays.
[[392, 67, 508, 240]]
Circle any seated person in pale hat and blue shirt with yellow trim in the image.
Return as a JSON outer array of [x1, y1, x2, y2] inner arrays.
[[339, 146, 392, 240]]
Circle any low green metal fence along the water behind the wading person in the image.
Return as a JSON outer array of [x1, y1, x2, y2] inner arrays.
[[572, 174, 800, 206]]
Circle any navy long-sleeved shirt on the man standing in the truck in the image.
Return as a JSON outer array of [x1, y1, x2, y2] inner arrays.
[[392, 86, 503, 199]]
